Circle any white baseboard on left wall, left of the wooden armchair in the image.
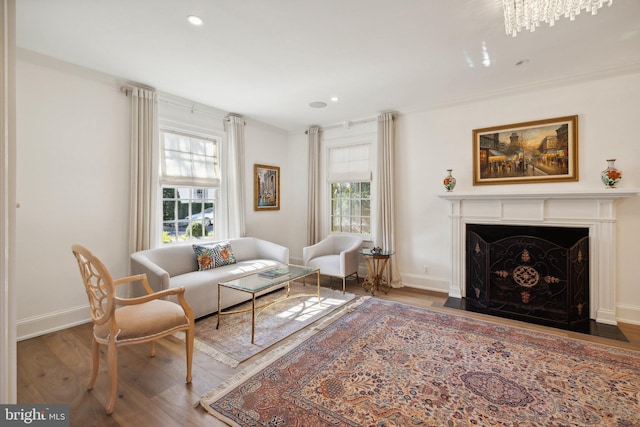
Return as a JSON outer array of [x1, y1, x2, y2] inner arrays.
[[16, 305, 91, 341]]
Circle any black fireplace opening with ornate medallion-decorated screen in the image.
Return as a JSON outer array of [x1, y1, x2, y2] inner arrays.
[[465, 224, 589, 331]]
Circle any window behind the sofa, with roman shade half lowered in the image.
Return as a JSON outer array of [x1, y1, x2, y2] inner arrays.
[[161, 130, 220, 243]]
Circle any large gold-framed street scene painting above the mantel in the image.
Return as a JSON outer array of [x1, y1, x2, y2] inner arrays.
[[473, 116, 578, 185]]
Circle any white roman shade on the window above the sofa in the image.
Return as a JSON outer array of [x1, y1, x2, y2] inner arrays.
[[160, 130, 220, 187]]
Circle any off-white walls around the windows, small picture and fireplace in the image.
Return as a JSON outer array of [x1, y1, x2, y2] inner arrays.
[[15, 51, 640, 338]]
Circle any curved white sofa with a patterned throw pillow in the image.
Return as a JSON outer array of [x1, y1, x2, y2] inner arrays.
[[131, 237, 289, 318]]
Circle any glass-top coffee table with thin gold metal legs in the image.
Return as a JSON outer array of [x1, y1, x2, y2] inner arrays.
[[216, 264, 320, 344]]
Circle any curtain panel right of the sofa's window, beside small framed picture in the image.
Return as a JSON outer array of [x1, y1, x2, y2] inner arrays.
[[216, 115, 245, 239]]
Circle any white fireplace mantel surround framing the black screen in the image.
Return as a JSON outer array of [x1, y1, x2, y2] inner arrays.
[[439, 188, 640, 325]]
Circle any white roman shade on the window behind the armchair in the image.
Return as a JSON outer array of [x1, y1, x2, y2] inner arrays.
[[328, 143, 371, 182]]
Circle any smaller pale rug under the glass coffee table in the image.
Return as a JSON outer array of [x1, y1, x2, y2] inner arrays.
[[180, 282, 355, 368]]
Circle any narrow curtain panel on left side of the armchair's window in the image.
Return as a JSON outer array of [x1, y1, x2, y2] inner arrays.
[[307, 127, 321, 246]]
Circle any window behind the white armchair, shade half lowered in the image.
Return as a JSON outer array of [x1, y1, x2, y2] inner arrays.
[[327, 142, 371, 240]]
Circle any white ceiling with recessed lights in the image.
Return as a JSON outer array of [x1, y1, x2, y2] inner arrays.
[[16, 0, 640, 131]]
